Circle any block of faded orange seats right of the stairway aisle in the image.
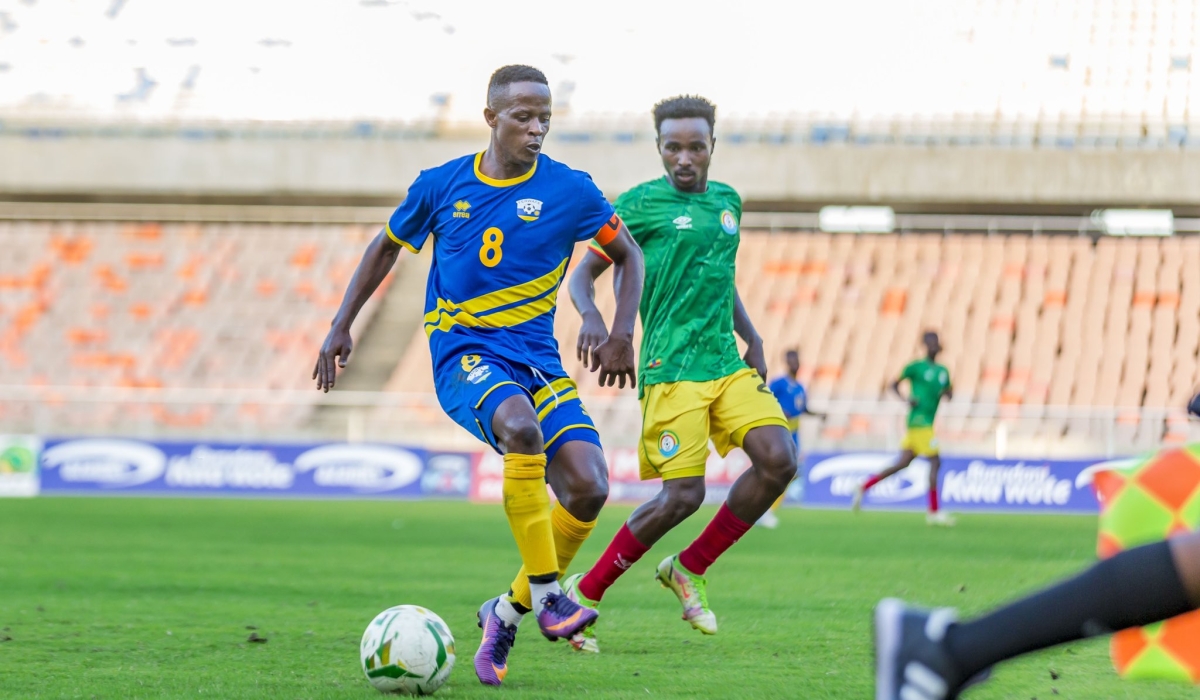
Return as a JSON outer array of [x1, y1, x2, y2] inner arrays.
[[386, 232, 1200, 453]]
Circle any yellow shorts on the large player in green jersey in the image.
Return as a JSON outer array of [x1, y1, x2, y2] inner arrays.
[[637, 367, 787, 480]]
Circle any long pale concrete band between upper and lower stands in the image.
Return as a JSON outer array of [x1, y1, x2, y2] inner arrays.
[[7, 130, 1200, 215]]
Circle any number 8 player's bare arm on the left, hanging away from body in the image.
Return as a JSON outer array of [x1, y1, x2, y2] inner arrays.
[[312, 231, 400, 391]]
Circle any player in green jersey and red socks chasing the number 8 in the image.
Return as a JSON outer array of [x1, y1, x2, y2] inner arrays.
[[563, 96, 796, 651]]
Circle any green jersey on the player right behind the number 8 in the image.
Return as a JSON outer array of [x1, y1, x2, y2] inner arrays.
[[592, 177, 746, 388]]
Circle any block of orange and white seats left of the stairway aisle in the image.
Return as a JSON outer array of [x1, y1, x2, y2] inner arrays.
[[0, 222, 386, 433]]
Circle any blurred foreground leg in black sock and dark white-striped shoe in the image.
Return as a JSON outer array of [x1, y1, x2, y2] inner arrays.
[[875, 395, 1200, 700]]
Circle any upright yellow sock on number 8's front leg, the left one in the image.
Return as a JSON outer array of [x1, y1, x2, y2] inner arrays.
[[504, 454, 558, 576]]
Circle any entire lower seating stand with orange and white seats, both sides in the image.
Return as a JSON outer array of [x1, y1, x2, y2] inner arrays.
[[0, 221, 1200, 450]]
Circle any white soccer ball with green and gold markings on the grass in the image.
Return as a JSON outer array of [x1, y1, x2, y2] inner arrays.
[[360, 605, 454, 695]]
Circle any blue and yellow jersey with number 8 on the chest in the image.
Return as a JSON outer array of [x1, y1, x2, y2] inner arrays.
[[386, 154, 617, 377]]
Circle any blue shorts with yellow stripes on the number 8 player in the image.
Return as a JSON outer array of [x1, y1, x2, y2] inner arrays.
[[434, 351, 601, 465]]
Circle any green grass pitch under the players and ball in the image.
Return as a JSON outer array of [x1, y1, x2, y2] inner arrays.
[[0, 498, 1195, 700]]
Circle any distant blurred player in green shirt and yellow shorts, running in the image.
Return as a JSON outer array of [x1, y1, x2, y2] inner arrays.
[[851, 330, 954, 526]]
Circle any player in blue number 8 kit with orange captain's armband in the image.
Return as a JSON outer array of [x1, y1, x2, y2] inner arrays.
[[313, 66, 643, 686]]
